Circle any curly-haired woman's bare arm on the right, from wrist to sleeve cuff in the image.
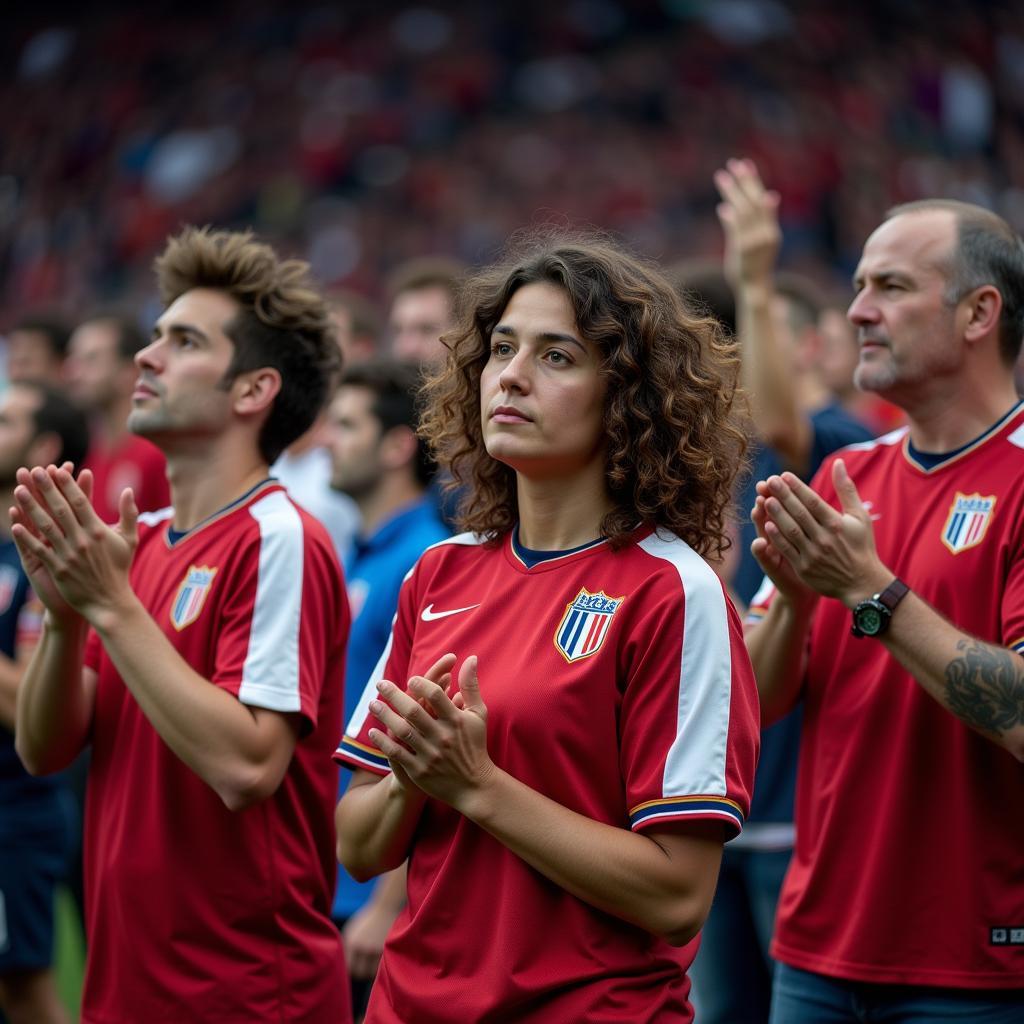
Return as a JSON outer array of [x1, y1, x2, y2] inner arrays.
[[455, 769, 722, 944]]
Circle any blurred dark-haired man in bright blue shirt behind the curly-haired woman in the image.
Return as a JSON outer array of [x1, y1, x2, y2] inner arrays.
[[325, 359, 449, 1015]]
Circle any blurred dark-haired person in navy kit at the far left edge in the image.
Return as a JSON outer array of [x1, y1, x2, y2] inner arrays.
[[0, 383, 88, 1024]]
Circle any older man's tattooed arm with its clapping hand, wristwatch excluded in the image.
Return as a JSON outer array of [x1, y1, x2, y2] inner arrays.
[[764, 459, 1024, 761]]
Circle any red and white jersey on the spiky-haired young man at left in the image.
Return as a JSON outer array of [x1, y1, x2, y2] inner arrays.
[[82, 482, 351, 1024]]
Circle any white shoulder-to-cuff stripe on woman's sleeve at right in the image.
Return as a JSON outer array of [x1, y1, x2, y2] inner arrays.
[[638, 534, 732, 797]]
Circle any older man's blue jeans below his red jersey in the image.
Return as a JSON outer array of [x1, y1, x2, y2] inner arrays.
[[771, 964, 1024, 1024]]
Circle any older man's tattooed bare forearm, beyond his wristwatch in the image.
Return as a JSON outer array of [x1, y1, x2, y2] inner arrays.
[[864, 591, 1024, 761]]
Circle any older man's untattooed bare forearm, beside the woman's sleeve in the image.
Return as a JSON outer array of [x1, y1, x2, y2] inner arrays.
[[743, 595, 813, 726]]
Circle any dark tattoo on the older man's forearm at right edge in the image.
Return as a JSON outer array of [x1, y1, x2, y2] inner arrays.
[[946, 640, 1024, 736]]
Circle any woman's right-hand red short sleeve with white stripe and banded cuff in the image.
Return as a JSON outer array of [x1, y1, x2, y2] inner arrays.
[[621, 551, 760, 839]]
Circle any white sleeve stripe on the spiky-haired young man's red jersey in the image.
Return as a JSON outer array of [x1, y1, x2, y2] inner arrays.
[[239, 490, 304, 711]]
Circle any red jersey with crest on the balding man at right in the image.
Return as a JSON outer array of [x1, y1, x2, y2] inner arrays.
[[753, 406, 1024, 988]]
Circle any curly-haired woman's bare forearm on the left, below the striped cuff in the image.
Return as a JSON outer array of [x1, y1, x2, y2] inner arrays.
[[334, 773, 426, 882]]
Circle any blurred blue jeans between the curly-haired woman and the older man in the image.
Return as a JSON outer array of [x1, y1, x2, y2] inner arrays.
[[689, 846, 791, 1024]]
